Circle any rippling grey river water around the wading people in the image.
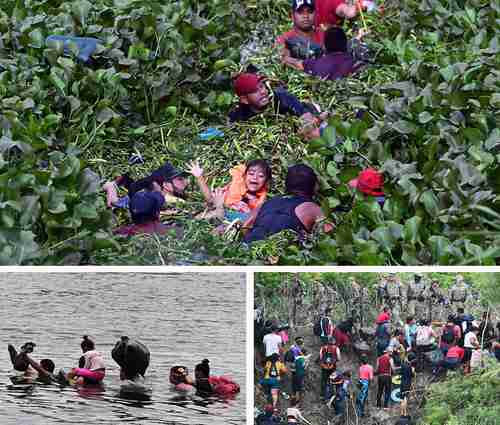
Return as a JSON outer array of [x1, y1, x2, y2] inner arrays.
[[0, 273, 246, 425]]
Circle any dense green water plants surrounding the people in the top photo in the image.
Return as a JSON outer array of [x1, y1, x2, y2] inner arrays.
[[0, 0, 500, 265]]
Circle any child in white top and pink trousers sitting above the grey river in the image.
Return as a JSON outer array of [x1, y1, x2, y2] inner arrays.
[[66, 335, 106, 384]]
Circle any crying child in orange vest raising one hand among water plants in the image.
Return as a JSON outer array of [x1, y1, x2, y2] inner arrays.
[[190, 159, 271, 222]]
